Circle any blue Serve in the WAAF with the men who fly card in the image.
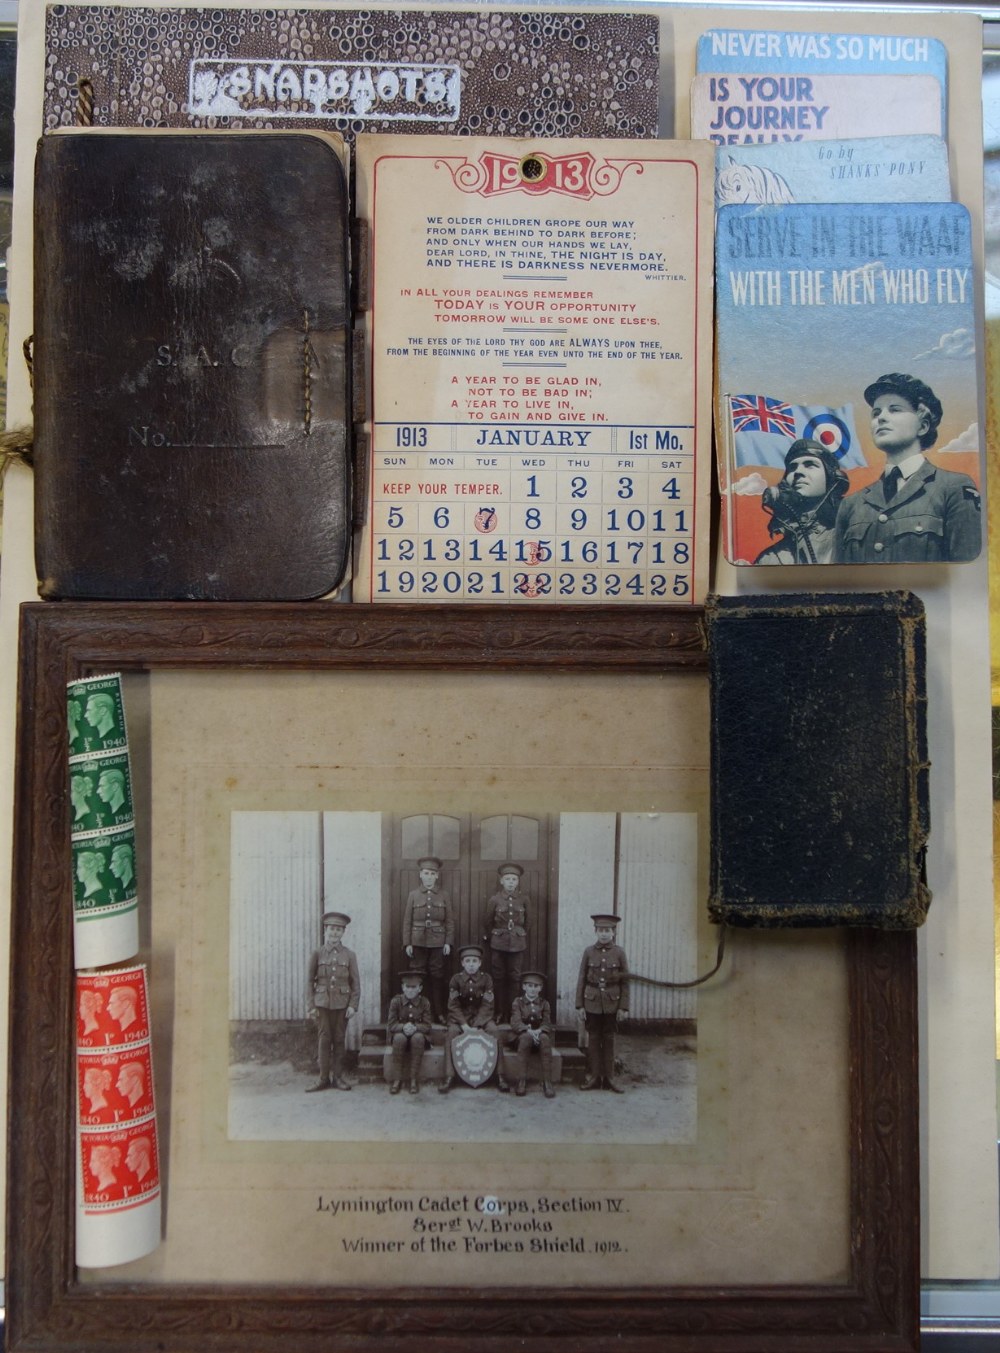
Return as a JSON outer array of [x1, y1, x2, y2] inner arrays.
[[716, 203, 981, 564]]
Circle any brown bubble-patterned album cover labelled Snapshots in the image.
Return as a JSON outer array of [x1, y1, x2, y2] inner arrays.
[[43, 4, 659, 141]]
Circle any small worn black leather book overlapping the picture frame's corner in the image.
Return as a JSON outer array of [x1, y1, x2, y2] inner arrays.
[[706, 593, 931, 930]]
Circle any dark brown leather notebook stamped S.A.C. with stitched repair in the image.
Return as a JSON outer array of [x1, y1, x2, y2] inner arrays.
[[34, 129, 350, 601]]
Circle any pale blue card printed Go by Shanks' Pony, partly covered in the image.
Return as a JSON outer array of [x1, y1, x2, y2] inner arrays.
[[716, 137, 951, 207]]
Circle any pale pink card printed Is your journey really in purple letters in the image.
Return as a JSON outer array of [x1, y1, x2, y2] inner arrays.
[[691, 73, 943, 146]]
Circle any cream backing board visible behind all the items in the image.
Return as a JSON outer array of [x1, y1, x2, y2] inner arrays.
[[0, 0, 1000, 1279]]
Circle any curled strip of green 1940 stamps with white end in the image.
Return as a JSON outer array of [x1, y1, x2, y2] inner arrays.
[[66, 672, 139, 967]]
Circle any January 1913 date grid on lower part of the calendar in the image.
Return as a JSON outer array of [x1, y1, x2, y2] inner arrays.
[[368, 423, 694, 605]]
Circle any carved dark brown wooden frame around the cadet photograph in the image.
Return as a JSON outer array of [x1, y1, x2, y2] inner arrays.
[[7, 603, 919, 1353]]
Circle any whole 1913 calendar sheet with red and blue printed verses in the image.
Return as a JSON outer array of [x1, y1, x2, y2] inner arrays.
[[355, 137, 714, 605]]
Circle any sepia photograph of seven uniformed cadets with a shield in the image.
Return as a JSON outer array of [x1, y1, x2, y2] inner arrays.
[[229, 801, 698, 1143]]
